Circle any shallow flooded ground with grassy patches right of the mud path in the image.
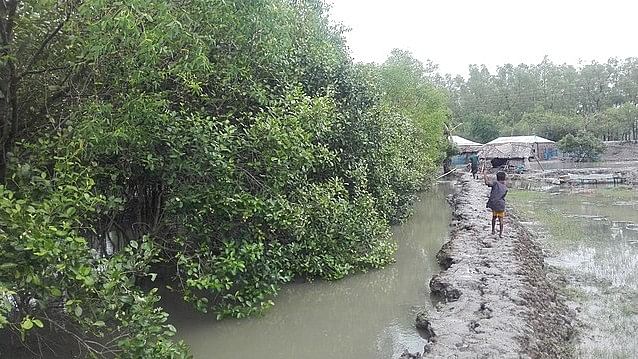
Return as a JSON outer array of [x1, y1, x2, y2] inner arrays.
[[508, 187, 638, 358]]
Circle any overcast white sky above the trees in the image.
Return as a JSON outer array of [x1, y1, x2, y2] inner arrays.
[[327, 0, 638, 75]]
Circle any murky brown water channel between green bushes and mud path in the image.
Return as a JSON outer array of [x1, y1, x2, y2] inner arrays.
[[164, 183, 453, 359]]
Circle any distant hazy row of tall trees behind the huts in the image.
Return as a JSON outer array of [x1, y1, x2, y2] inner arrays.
[[437, 58, 638, 141]]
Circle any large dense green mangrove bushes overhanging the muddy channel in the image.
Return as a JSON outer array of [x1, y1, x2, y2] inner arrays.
[[0, 0, 448, 358]]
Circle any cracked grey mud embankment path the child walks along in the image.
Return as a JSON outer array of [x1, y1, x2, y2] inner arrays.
[[417, 175, 574, 358]]
